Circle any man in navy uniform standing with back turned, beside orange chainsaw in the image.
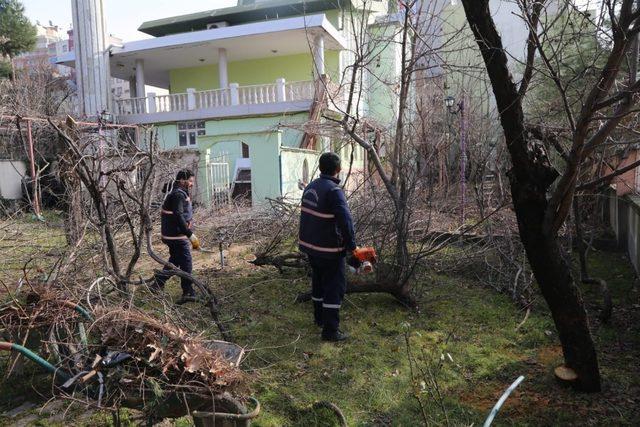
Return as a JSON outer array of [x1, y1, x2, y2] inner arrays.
[[298, 153, 356, 341]]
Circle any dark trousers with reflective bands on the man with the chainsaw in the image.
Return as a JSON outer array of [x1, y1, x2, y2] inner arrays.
[[309, 256, 347, 335]]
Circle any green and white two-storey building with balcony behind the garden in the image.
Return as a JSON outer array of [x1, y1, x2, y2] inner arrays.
[[58, 0, 400, 205]]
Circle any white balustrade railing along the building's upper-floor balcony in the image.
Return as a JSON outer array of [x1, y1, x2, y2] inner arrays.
[[114, 79, 315, 116]]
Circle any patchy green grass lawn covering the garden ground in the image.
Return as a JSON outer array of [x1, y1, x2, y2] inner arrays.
[[0, 214, 640, 426]]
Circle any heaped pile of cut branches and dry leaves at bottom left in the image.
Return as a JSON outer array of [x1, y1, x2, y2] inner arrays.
[[0, 286, 247, 418]]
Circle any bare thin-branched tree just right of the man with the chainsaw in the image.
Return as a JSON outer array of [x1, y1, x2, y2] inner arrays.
[[325, 0, 490, 304]]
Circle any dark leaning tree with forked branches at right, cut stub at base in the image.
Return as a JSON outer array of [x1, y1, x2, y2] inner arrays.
[[462, 0, 640, 392]]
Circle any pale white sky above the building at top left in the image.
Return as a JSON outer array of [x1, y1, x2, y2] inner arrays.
[[22, 0, 237, 41]]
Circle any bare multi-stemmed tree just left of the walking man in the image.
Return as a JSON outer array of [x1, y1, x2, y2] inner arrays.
[[50, 118, 231, 340]]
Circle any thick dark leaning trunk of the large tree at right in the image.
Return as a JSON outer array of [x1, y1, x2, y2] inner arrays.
[[462, 0, 600, 392]]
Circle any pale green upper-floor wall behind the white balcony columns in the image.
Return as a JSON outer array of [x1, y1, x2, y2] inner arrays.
[[169, 51, 339, 93]]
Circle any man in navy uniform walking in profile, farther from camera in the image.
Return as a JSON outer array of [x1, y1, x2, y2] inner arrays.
[[155, 169, 200, 304]]
